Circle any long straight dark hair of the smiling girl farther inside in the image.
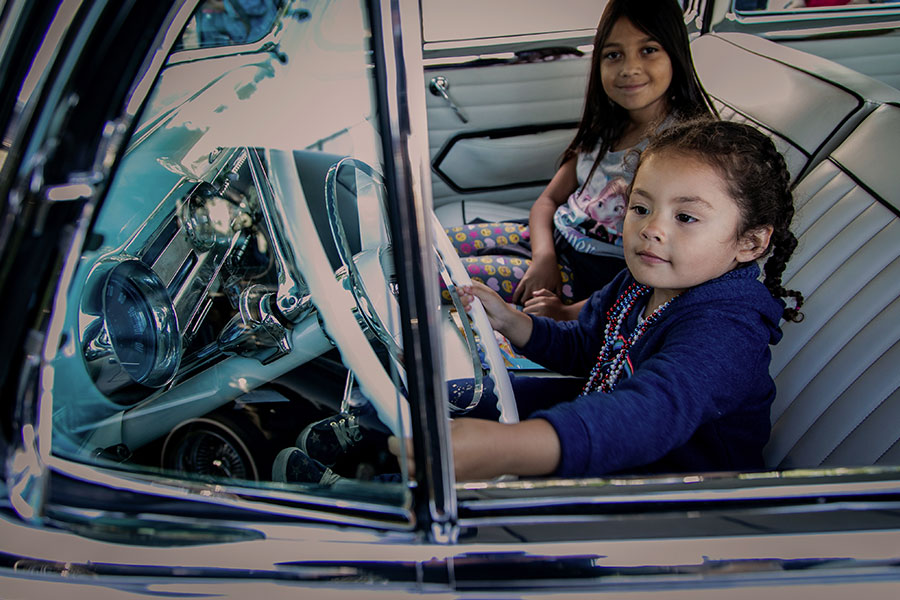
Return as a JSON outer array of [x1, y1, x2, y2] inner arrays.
[[562, 0, 716, 168]]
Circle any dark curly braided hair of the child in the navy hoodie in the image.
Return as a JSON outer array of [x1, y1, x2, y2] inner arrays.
[[638, 119, 803, 322]]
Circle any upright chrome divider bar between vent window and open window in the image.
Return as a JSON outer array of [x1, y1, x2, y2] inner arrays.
[[371, 0, 457, 543]]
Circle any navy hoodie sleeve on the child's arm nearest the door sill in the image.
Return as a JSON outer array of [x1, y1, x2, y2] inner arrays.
[[532, 313, 774, 476]]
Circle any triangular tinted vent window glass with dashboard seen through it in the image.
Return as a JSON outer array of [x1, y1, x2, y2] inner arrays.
[[47, 0, 409, 501]]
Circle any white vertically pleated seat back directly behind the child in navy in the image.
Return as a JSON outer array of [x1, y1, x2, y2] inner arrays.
[[765, 104, 900, 469]]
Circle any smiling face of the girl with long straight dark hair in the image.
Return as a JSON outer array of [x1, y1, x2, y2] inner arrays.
[[600, 17, 672, 122]]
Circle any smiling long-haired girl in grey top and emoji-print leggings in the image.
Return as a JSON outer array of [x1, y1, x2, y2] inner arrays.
[[444, 0, 713, 319]]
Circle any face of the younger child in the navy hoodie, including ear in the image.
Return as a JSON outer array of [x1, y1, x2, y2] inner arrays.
[[622, 151, 768, 303]]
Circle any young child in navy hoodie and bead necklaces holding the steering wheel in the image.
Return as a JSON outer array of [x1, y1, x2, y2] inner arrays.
[[393, 121, 803, 480]]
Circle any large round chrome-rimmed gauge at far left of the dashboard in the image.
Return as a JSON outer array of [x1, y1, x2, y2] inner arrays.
[[102, 260, 181, 387]]
